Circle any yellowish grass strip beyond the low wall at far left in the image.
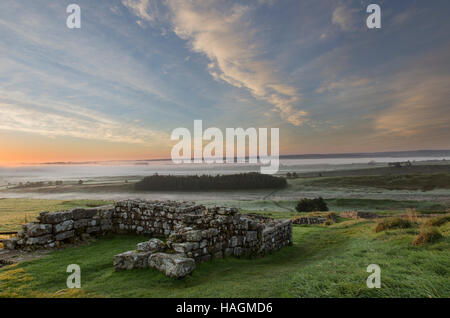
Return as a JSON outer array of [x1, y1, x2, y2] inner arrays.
[[0, 199, 112, 232]]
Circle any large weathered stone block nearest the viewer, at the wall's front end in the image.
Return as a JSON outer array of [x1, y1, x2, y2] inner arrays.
[[148, 253, 195, 278]]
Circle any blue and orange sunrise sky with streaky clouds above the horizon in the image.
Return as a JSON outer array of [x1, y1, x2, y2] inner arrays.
[[0, 0, 450, 164]]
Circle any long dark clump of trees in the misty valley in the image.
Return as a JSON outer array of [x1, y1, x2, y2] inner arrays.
[[135, 173, 287, 191]]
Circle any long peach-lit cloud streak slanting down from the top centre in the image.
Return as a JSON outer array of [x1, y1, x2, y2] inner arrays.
[[123, 0, 308, 126]]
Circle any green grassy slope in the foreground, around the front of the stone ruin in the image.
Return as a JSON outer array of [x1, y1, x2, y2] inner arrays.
[[0, 221, 450, 297]]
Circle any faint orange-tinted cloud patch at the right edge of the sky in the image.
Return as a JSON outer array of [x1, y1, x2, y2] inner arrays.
[[374, 46, 450, 141]]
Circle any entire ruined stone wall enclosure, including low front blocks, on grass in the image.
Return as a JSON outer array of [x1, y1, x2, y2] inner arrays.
[[3, 200, 292, 278]]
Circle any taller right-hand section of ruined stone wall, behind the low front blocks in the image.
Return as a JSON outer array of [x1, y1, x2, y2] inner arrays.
[[113, 200, 292, 262]]
